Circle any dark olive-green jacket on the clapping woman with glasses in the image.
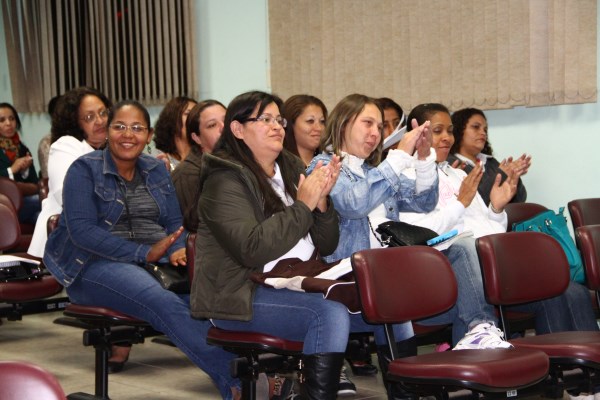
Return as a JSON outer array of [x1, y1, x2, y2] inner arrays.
[[191, 150, 339, 321]]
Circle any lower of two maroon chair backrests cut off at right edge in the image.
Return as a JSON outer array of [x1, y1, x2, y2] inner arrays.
[[575, 225, 600, 290]]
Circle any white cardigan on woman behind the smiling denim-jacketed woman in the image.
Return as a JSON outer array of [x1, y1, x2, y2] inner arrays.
[[27, 136, 94, 257]]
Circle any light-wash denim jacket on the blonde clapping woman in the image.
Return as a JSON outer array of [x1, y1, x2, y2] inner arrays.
[[307, 153, 438, 262]]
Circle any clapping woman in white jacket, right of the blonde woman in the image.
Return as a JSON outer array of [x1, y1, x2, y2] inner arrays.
[[400, 103, 598, 338]]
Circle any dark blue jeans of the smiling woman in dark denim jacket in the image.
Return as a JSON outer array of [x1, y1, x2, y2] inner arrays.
[[67, 260, 239, 399]]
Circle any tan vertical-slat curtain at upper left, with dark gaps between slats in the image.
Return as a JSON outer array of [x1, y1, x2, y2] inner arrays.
[[0, 0, 199, 112]]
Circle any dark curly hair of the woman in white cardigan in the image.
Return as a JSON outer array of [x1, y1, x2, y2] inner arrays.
[[50, 86, 112, 143]]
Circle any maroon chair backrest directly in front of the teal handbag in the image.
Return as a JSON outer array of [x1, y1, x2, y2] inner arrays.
[[475, 232, 570, 306]]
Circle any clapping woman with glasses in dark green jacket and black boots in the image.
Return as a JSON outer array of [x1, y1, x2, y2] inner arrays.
[[192, 92, 412, 400]]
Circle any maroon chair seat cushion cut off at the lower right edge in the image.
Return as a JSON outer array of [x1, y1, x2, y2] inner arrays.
[[510, 331, 600, 364]]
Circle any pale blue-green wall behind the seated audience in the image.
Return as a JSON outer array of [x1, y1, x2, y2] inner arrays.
[[0, 0, 600, 219]]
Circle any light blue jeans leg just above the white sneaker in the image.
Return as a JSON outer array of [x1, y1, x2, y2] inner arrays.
[[415, 237, 498, 344]]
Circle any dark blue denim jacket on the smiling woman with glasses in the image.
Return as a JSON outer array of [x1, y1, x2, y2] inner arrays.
[[44, 149, 185, 286]]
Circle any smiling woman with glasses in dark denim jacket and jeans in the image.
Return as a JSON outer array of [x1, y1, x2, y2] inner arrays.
[[44, 101, 239, 399]]
